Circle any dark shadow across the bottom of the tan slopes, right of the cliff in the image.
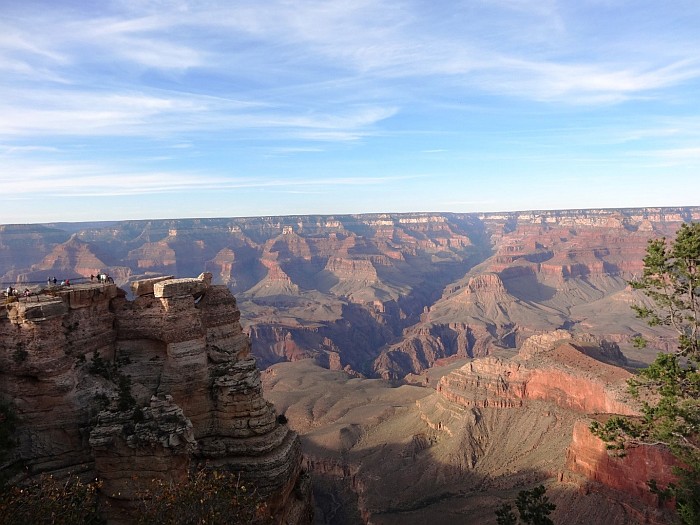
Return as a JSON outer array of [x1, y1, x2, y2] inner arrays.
[[305, 442, 644, 525]]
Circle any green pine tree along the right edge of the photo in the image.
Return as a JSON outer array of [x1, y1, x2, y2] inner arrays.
[[591, 223, 700, 525]]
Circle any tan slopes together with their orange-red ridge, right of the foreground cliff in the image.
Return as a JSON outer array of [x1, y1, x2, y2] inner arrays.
[[263, 330, 673, 525]]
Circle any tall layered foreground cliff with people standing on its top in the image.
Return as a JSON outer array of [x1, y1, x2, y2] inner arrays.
[[0, 274, 310, 523]]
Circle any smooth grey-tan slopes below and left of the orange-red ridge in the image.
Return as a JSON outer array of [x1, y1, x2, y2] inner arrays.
[[263, 342, 663, 525]]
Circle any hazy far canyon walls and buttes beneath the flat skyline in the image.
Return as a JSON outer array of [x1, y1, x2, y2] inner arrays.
[[0, 207, 700, 379]]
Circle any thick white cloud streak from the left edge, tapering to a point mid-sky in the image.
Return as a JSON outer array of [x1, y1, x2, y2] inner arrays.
[[0, 90, 396, 140]]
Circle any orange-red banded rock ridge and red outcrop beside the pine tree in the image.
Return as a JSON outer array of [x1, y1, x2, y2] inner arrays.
[[438, 330, 675, 523]]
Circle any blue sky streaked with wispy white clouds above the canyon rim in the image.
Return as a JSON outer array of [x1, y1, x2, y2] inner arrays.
[[0, 0, 700, 224]]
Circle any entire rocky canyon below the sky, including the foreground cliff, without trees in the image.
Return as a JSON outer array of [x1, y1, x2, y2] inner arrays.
[[0, 207, 700, 525]]
